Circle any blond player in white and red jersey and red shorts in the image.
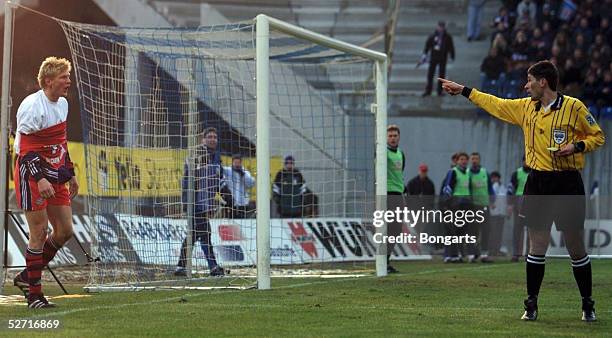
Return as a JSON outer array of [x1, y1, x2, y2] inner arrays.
[[13, 57, 79, 309]]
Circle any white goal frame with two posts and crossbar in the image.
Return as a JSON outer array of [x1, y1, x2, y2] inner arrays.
[[255, 14, 387, 289]]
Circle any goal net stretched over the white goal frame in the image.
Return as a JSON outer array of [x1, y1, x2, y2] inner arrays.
[[60, 16, 388, 290]]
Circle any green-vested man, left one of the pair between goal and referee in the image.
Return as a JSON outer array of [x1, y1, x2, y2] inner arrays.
[[442, 152, 472, 263]]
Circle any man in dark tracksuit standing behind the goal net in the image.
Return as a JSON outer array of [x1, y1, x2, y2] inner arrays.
[[174, 127, 225, 276]]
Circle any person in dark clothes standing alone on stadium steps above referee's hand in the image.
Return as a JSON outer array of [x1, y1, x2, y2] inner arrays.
[[423, 21, 455, 96]]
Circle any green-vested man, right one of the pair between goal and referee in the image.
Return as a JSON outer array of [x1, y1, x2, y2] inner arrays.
[[466, 152, 495, 263]]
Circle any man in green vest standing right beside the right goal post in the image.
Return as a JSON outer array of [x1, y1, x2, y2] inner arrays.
[[387, 124, 406, 273]]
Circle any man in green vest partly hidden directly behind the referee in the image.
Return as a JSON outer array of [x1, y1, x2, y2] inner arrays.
[[508, 156, 531, 262]]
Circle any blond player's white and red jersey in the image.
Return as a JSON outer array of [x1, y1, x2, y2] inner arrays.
[[14, 89, 68, 155]]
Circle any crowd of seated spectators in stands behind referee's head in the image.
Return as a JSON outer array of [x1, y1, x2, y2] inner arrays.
[[481, 0, 612, 117]]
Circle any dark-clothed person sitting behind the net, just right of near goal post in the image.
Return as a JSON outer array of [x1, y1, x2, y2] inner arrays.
[[272, 155, 307, 218]]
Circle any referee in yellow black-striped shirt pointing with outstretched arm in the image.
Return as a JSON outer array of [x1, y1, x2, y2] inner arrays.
[[439, 61, 604, 322]]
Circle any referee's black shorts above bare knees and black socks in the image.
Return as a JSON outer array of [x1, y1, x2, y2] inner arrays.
[[520, 170, 586, 231]]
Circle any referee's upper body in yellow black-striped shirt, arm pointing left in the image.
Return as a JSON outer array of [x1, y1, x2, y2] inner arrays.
[[438, 72, 605, 171]]
